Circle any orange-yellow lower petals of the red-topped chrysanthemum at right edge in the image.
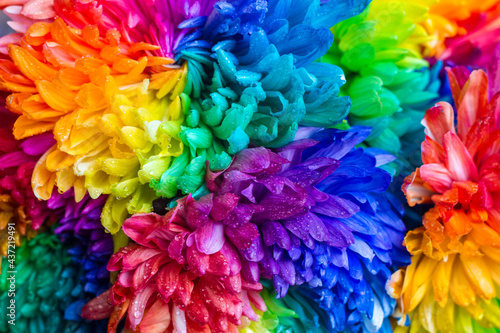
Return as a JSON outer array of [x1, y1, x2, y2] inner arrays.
[[388, 223, 500, 333]]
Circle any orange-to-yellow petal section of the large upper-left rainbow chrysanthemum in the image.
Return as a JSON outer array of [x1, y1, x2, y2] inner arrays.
[[0, 19, 187, 233]]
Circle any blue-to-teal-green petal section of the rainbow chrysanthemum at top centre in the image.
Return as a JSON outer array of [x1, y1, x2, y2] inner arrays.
[[152, 0, 366, 197]]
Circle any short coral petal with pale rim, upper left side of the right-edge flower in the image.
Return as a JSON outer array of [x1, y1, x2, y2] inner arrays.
[[422, 102, 455, 145]]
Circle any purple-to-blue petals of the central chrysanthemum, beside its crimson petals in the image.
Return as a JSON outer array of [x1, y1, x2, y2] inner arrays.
[[147, 128, 407, 332]]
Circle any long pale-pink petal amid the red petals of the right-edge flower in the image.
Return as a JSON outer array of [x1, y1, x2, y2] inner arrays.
[[443, 133, 478, 181]]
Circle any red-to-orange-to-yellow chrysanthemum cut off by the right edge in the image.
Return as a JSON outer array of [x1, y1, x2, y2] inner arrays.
[[389, 67, 500, 332]]
